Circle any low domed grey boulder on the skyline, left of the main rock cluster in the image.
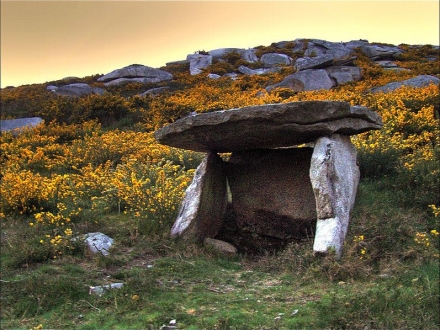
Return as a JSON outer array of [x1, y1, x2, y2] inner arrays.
[[98, 64, 173, 83]]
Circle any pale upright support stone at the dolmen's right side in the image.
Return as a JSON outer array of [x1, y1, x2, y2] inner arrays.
[[310, 134, 360, 258]]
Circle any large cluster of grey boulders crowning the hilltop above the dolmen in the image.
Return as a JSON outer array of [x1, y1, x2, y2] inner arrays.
[[168, 39, 426, 92]]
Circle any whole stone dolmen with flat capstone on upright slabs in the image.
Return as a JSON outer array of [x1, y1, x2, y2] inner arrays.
[[155, 101, 382, 258]]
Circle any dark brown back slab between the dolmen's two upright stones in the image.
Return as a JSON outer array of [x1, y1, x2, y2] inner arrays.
[[226, 148, 316, 239]]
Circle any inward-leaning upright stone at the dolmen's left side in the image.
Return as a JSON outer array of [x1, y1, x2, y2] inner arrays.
[[171, 153, 227, 240]]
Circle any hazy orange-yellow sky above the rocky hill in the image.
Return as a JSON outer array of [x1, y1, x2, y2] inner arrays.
[[1, 0, 439, 88]]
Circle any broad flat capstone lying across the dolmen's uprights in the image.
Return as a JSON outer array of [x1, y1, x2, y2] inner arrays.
[[155, 101, 382, 152]]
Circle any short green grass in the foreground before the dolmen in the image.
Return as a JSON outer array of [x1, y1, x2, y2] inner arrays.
[[1, 182, 440, 330]]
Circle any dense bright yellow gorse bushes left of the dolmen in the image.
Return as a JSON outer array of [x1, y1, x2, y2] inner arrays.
[[0, 122, 201, 257]]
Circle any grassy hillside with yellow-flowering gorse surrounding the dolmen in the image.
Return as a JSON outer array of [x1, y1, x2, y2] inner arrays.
[[0, 45, 440, 329]]
